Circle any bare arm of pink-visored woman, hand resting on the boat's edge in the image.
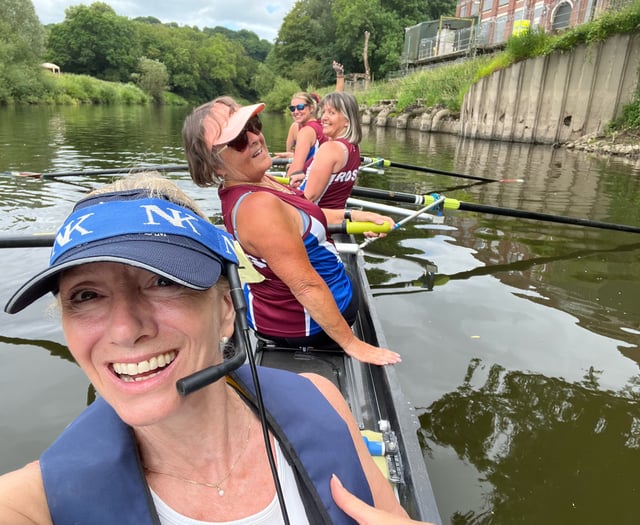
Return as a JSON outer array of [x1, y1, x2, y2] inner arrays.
[[236, 192, 400, 365]]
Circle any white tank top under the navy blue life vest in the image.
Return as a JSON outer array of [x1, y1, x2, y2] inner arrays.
[[151, 441, 309, 525]]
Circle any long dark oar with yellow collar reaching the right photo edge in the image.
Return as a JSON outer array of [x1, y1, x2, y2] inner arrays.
[[351, 186, 640, 233]]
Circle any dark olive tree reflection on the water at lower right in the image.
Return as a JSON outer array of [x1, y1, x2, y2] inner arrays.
[[420, 359, 640, 525]]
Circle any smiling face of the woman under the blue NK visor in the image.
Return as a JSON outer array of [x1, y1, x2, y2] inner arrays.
[[59, 262, 234, 425]]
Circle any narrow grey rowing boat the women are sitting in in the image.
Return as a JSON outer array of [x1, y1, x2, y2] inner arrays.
[[255, 234, 442, 525]]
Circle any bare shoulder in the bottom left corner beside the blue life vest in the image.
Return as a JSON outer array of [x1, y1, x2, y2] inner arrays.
[[0, 461, 52, 525]]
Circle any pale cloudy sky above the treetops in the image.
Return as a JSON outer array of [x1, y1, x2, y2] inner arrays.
[[31, 0, 295, 42]]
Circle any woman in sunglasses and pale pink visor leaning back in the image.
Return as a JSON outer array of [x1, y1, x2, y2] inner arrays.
[[182, 97, 400, 365]]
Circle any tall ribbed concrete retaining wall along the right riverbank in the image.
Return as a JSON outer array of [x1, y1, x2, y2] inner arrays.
[[362, 34, 640, 144]]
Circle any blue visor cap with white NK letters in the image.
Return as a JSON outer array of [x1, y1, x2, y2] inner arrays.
[[5, 190, 238, 314]]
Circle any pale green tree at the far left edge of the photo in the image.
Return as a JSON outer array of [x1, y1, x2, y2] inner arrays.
[[0, 0, 44, 103]]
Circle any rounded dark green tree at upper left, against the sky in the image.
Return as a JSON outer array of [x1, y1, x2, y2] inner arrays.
[[49, 2, 141, 82]]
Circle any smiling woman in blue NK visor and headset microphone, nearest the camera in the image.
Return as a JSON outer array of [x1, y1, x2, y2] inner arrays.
[[0, 176, 420, 525]]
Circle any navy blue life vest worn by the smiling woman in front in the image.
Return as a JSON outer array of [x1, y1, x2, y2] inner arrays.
[[40, 366, 373, 525]]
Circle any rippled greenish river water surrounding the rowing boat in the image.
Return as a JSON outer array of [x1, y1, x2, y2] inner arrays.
[[0, 107, 640, 525]]
